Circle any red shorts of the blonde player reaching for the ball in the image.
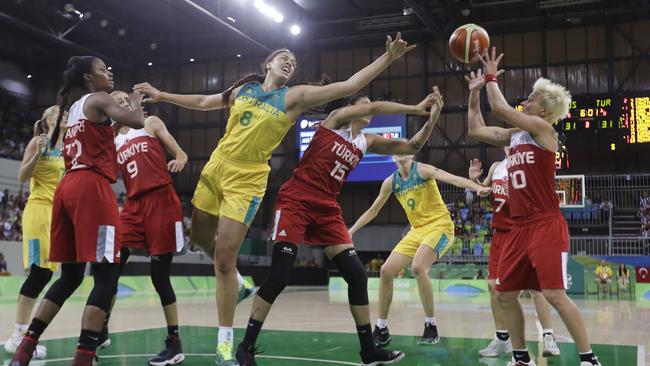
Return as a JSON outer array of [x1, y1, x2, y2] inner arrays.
[[496, 214, 569, 291]]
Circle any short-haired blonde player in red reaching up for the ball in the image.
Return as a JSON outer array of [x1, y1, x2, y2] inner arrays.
[[467, 48, 600, 366]]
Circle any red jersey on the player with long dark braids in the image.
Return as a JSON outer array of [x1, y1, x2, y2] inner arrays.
[[63, 94, 117, 183]]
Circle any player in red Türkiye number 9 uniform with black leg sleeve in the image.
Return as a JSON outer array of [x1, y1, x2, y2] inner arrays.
[[111, 91, 187, 366]]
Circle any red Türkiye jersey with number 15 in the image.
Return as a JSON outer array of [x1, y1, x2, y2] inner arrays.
[[292, 127, 367, 198]]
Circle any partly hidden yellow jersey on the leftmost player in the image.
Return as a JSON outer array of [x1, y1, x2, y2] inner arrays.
[[29, 147, 65, 203]]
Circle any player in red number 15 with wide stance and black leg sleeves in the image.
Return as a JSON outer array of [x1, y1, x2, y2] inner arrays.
[[236, 88, 443, 366]]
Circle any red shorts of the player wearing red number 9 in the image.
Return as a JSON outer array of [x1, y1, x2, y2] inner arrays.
[[120, 185, 185, 255]]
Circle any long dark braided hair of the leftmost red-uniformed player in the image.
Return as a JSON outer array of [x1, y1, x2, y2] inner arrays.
[[50, 56, 97, 148]]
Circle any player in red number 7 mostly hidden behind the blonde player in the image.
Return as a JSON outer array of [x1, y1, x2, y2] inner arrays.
[[468, 157, 560, 357]]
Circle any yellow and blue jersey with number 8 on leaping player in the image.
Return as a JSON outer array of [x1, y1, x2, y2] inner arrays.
[[212, 82, 293, 163]]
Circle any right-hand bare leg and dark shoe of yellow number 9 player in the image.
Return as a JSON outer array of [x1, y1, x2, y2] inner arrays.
[[411, 245, 440, 344]]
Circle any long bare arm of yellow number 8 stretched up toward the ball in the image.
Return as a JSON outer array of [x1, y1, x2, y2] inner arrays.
[[285, 33, 415, 116]]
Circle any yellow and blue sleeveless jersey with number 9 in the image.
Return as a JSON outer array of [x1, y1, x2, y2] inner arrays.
[[393, 162, 451, 228]]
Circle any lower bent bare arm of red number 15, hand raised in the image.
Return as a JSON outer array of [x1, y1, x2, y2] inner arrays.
[[366, 91, 444, 155]]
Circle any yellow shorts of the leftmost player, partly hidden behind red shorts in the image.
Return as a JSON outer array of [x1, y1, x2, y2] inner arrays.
[[23, 200, 59, 271]]
